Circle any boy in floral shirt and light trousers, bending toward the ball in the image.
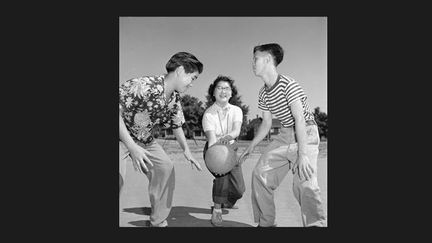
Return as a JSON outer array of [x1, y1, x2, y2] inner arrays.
[[119, 52, 203, 227]]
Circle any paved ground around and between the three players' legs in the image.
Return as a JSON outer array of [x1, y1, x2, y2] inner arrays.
[[119, 140, 327, 227]]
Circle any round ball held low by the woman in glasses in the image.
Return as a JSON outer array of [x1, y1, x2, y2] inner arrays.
[[204, 143, 237, 175]]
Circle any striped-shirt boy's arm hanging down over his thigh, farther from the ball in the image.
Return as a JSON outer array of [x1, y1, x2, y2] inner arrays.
[[290, 99, 314, 180]]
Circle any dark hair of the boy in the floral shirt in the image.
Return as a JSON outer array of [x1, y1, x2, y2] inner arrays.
[[165, 52, 203, 73]]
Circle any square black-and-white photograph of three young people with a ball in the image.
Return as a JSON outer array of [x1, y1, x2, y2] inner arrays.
[[118, 16, 328, 227]]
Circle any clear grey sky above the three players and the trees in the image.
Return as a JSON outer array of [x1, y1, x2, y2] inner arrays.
[[119, 17, 327, 119]]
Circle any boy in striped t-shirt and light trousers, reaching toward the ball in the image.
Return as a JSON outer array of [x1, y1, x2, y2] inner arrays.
[[240, 43, 326, 227]]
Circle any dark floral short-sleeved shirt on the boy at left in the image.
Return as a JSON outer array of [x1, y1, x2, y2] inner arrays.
[[119, 75, 185, 144]]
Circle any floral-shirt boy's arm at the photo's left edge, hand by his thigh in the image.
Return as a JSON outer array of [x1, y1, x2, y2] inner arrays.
[[119, 113, 153, 173]]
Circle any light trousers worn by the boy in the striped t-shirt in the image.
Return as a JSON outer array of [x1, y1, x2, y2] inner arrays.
[[252, 125, 326, 227]]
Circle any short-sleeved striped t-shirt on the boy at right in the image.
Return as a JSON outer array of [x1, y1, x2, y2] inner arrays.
[[258, 75, 314, 127]]
